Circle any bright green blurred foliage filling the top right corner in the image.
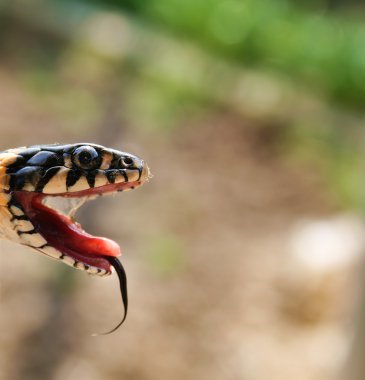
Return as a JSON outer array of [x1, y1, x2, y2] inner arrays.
[[84, 0, 365, 107]]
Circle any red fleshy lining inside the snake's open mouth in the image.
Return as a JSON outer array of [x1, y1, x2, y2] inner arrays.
[[13, 182, 139, 272]]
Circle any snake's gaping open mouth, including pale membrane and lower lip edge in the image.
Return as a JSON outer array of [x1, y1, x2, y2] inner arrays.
[[12, 181, 141, 275]]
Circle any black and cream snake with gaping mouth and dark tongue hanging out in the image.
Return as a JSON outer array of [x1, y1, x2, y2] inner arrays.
[[0, 143, 151, 333]]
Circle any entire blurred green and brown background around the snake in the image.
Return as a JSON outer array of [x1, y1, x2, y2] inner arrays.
[[0, 0, 365, 380]]
